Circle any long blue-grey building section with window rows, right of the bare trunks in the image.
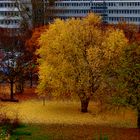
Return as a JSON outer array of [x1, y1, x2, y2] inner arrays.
[[45, 0, 140, 25]]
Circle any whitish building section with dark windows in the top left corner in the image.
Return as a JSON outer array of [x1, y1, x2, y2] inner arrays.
[[0, 0, 32, 29]]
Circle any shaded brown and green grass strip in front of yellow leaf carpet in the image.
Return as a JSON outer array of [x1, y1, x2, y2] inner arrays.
[[11, 124, 140, 140]]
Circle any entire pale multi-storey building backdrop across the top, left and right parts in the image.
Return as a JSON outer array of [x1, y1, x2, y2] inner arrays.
[[0, 0, 140, 29]]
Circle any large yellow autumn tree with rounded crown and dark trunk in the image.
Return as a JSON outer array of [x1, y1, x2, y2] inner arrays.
[[37, 14, 127, 112]]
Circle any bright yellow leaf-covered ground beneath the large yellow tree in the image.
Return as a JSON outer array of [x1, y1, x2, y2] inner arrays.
[[1, 99, 136, 128]]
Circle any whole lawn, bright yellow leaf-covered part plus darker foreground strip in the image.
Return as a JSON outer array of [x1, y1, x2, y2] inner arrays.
[[0, 87, 140, 140]]
